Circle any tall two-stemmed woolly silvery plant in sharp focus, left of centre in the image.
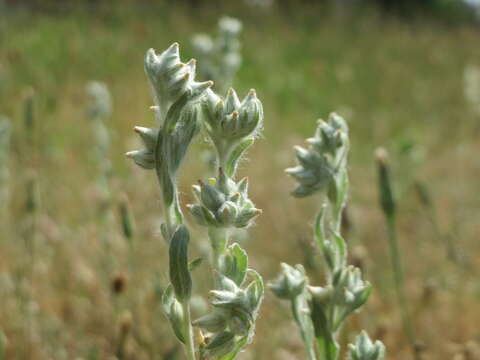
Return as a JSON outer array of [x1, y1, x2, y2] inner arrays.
[[127, 43, 263, 360]]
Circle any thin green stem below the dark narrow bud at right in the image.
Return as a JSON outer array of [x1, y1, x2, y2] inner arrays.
[[386, 216, 416, 353]]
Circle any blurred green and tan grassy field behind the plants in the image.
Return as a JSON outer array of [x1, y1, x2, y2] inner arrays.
[[0, 1, 480, 359]]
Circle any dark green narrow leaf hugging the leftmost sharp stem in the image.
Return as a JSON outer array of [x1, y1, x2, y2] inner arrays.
[[169, 225, 192, 301]]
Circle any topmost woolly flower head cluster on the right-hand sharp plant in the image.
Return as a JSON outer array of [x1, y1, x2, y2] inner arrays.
[[286, 113, 349, 197]]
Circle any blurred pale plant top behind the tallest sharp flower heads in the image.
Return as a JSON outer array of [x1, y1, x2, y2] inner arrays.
[[192, 16, 242, 93]]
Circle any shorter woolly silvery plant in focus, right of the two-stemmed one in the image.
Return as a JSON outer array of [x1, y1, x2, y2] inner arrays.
[[269, 114, 380, 360]]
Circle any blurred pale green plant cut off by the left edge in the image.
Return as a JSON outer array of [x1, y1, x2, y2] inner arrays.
[[0, 116, 11, 219]]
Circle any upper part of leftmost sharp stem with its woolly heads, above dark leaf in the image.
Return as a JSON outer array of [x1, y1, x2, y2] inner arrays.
[[127, 43, 213, 242]]
